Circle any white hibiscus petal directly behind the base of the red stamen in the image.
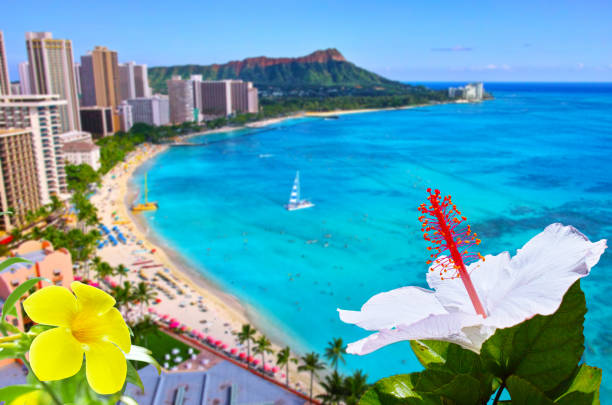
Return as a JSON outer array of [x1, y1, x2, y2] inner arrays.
[[427, 252, 510, 314]]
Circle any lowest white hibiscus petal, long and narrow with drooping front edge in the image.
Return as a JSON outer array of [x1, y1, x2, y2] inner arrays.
[[346, 313, 482, 355]]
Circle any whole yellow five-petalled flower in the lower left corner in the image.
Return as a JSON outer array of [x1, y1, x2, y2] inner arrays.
[[23, 281, 131, 394]]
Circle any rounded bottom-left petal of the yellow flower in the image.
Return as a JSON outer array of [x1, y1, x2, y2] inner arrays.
[[30, 327, 83, 381]]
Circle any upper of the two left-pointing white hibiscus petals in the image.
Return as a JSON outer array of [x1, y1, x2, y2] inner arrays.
[[338, 287, 447, 330]]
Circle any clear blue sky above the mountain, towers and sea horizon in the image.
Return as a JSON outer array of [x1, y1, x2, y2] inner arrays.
[[0, 0, 612, 81]]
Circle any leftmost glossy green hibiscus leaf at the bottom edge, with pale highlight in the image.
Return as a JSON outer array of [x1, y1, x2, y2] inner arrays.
[[359, 373, 441, 405]]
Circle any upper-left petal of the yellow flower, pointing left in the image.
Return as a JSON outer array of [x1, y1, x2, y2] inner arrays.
[[23, 285, 77, 327]]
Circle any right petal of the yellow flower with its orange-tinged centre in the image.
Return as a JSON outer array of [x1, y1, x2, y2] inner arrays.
[[72, 308, 131, 353]]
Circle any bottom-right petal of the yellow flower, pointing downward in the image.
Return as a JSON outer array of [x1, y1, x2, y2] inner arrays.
[[85, 342, 127, 395]]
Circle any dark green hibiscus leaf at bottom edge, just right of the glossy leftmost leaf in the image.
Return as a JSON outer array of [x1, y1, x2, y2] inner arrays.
[[415, 369, 482, 405]]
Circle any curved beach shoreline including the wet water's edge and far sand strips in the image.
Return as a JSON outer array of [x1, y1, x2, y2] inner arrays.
[[91, 116, 318, 391]]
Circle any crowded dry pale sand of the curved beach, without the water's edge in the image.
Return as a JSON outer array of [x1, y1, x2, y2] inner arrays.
[[91, 124, 318, 392]]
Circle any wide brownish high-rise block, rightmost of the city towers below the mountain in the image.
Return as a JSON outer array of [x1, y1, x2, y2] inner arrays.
[[200, 80, 259, 118]]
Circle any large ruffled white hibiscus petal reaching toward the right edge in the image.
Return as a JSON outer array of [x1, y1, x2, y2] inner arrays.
[[485, 224, 606, 328]]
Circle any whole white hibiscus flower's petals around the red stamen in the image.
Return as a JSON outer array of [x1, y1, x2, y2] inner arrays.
[[338, 211, 606, 355]]
